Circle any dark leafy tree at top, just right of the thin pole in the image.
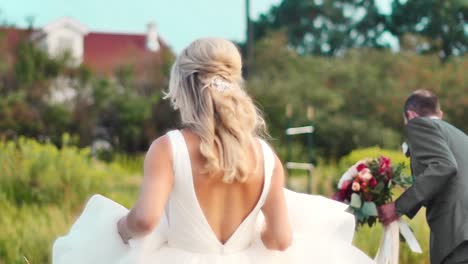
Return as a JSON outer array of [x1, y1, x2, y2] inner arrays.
[[254, 0, 386, 56]]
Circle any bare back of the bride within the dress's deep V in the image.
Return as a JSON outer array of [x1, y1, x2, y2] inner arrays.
[[182, 130, 264, 244]]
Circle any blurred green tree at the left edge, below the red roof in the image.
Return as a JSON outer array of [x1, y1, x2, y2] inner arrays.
[[0, 40, 71, 142]]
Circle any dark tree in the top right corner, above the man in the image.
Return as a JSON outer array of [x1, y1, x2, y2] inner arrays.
[[387, 0, 468, 60]]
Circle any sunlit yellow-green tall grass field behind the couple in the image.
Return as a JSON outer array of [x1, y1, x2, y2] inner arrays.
[[0, 139, 429, 264]]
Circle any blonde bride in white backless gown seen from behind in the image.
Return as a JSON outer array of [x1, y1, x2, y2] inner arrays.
[[53, 38, 373, 264]]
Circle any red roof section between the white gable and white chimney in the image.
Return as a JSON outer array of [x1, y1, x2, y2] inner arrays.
[[83, 32, 162, 74]]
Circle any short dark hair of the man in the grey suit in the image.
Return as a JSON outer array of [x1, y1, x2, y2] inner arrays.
[[404, 89, 440, 116]]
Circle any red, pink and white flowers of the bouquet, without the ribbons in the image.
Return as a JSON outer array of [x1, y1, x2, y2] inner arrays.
[[333, 156, 412, 226]]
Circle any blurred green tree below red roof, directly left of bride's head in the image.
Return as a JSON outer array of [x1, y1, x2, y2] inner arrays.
[[73, 49, 178, 152]]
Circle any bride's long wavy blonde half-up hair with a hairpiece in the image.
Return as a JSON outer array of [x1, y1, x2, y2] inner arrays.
[[165, 38, 266, 183]]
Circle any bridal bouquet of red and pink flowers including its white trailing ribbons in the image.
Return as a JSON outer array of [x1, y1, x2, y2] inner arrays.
[[333, 156, 422, 264]]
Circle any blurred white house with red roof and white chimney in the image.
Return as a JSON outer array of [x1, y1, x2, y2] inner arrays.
[[0, 17, 167, 75]]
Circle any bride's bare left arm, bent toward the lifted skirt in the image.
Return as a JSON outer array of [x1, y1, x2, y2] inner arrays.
[[118, 136, 174, 242]]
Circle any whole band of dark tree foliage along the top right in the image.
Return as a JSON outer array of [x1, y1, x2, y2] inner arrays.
[[254, 0, 468, 60]]
